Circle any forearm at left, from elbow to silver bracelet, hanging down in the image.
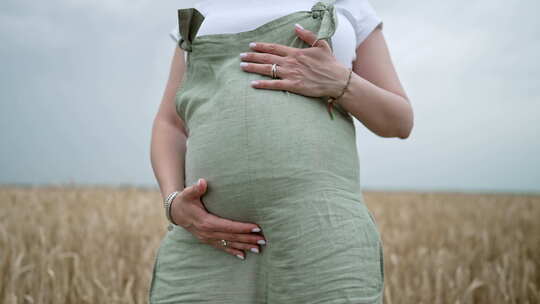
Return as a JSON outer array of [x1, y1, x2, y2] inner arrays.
[[150, 119, 187, 199]]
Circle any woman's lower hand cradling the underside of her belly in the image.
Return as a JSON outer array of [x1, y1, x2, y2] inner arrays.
[[171, 178, 266, 259]]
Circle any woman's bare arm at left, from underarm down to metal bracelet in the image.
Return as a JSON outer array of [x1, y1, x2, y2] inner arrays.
[[150, 46, 187, 199]]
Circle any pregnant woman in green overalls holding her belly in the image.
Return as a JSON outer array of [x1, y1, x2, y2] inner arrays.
[[149, 0, 413, 304]]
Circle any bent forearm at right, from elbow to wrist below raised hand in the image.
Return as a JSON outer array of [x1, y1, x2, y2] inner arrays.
[[336, 68, 413, 138]]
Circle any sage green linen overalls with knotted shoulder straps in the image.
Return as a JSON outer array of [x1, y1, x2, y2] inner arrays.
[[149, 1, 384, 304]]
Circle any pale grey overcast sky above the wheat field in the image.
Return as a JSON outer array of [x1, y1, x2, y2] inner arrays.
[[0, 0, 540, 192]]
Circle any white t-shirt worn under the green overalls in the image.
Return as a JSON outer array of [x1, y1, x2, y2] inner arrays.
[[169, 0, 382, 68]]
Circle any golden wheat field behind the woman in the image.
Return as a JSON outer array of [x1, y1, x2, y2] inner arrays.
[[0, 185, 540, 304]]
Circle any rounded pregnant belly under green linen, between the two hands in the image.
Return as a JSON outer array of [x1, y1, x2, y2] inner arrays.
[[179, 86, 361, 221]]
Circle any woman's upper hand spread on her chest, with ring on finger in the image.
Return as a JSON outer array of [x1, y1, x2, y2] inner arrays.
[[240, 27, 349, 97]]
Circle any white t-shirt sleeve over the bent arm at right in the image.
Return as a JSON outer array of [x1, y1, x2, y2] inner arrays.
[[335, 0, 383, 47]]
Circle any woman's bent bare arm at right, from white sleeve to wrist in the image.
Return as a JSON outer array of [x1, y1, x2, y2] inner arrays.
[[337, 28, 413, 139]]
